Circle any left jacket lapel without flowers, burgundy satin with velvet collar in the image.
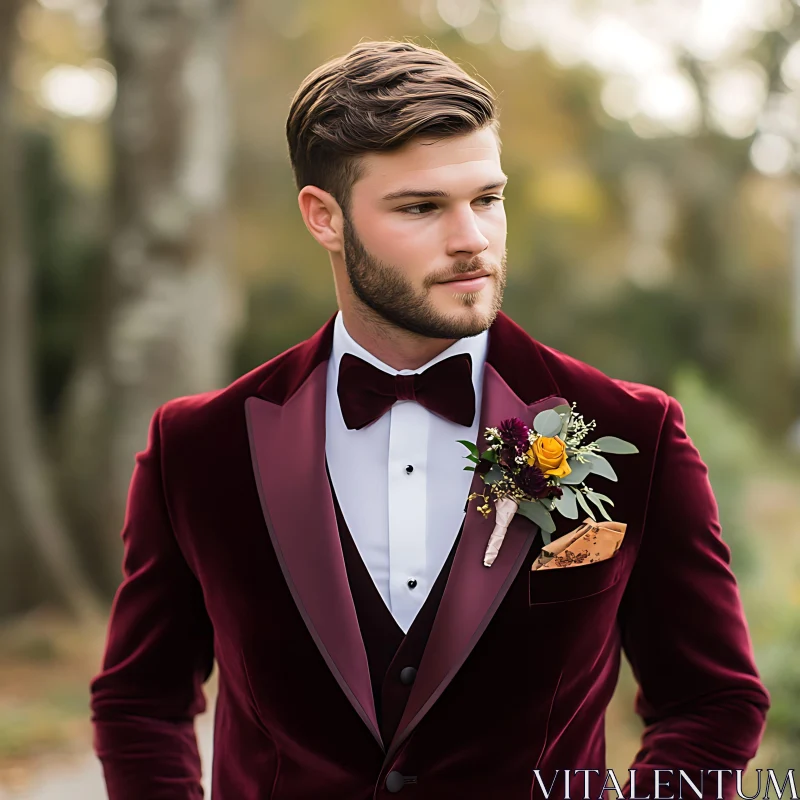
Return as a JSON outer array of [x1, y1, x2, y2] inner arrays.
[[245, 317, 385, 750]]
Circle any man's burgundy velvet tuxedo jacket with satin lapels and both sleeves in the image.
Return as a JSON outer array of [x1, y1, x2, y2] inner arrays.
[[91, 313, 770, 800]]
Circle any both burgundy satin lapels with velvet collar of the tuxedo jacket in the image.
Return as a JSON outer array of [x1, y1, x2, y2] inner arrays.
[[245, 312, 567, 763]]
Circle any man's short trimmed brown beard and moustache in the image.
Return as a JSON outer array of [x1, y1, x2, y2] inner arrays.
[[343, 213, 506, 339]]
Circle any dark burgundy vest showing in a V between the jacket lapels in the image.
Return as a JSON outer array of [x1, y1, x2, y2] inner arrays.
[[326, 464, 464, 743]]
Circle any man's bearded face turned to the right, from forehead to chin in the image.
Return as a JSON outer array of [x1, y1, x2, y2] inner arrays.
[[343, 129, 506, 339]]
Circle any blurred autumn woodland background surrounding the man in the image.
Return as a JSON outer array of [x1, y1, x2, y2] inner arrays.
[[0, 0, 800, 800]]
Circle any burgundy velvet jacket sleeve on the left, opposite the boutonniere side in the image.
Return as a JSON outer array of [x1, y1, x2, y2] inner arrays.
[[90, 406, 214, 800]]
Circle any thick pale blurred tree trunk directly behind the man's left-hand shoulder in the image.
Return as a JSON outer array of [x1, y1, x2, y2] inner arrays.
[[57, 0, 239, 591]]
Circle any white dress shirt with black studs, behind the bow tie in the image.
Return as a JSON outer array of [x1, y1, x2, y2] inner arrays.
[[325, 311, 489, 633]]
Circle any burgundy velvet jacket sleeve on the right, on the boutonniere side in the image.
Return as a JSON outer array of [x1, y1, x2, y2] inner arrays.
[[619, 397, 770, 800]]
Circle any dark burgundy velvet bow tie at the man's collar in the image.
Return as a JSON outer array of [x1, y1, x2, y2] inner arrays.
[[336, 353, 475, 430]]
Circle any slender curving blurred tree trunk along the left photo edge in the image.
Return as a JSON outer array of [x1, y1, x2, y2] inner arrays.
[[0, 0, 103, 622]]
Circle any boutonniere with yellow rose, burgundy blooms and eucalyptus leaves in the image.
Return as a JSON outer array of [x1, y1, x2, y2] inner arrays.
[[458, 403, 639, 567]]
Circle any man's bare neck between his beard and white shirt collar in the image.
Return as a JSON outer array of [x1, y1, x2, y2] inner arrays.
[[342, 309, 458, 370]]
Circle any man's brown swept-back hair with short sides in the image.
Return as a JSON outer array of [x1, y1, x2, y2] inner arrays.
[[286, 41, 499, 214]]
